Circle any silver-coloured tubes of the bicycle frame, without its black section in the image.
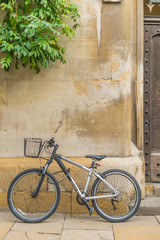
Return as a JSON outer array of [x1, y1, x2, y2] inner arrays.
[[60, 156, 117, 200]]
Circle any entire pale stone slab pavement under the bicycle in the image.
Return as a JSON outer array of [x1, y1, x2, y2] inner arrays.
[[0, 212, 160, 240]]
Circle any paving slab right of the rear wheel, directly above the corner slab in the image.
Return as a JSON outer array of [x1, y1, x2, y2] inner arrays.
[[113, 216, 159, 226]]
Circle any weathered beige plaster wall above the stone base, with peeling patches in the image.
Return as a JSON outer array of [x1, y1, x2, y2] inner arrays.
[[0, 0, 136, 157]]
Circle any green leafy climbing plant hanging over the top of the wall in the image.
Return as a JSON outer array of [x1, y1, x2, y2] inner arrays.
[[0, 0, 80, 73]]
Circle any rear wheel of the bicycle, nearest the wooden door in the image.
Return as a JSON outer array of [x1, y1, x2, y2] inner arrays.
[[91, 170, 141, 222]]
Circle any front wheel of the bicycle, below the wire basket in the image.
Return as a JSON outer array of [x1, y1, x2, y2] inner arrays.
[[8, 168, 60, 223]]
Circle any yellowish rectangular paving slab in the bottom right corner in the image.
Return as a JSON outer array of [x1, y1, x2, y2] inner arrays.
[[113, 225, 160, 240]]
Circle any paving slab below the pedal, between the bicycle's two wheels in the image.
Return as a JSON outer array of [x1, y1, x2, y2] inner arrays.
[[64, 215, 112, 230]]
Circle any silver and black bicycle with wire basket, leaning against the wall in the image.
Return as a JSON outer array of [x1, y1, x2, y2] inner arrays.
[[7, 138, 141, 223]]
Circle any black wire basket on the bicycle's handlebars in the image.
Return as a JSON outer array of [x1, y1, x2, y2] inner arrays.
[[24, 138, 42, 158]]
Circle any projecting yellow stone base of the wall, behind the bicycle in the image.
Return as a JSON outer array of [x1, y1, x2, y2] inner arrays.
[[0, 156, 145, 213]]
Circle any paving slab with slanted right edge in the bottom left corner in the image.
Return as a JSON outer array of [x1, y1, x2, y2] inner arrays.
[[0, 213, 16, 240]]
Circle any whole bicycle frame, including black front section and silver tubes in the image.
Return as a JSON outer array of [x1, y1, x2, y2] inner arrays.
[[45, 153, 117, 201]]
